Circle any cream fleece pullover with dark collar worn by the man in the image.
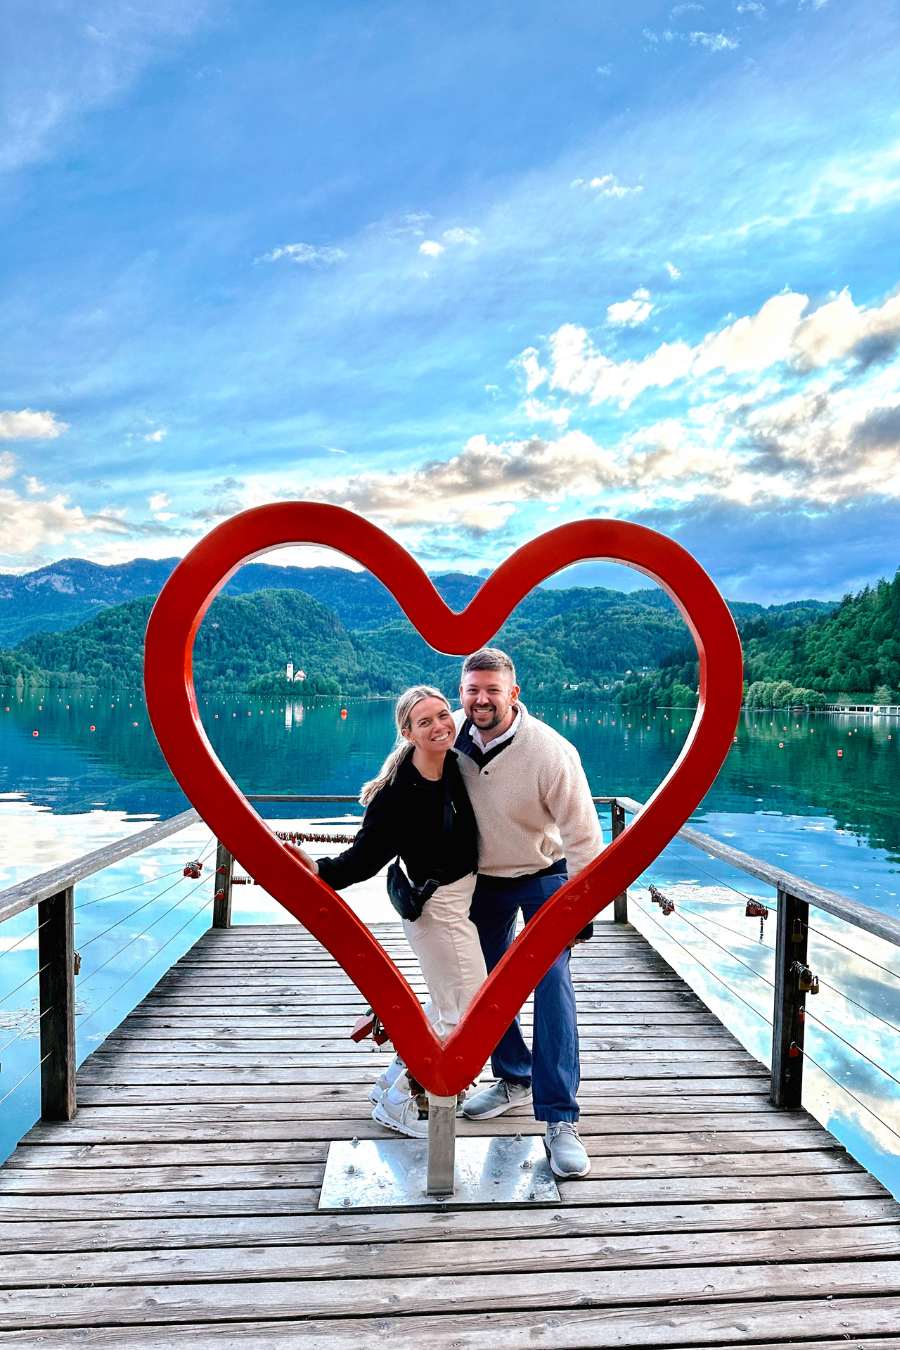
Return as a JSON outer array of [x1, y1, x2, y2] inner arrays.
[[453, 703, 603, 876]]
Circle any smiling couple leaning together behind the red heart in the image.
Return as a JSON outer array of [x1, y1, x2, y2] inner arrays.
[[296, 647, 603, 1177]]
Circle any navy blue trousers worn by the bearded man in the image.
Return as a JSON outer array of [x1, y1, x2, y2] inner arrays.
[[470, 863, 582, 1121]]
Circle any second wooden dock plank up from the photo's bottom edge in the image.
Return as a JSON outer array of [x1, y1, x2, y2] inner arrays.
[[0, 1260, 900, 1343]]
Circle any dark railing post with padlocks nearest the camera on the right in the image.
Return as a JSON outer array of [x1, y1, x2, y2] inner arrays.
[[769, 890, 810, 1108]]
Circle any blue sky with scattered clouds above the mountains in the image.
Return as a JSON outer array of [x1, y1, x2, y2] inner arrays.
[[0, 0, 900, 602]]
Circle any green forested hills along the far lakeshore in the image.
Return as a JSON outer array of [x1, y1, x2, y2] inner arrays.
[[0, 568, 900, 707]]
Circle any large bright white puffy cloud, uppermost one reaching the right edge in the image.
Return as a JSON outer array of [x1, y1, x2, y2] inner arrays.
[[539, 290, 900, 408]]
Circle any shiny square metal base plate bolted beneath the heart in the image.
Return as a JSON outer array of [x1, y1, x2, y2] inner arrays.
[[318, 1135, 560, 1212]]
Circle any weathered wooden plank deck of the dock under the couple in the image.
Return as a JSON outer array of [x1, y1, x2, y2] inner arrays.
[[0, 923, 900, 1350]]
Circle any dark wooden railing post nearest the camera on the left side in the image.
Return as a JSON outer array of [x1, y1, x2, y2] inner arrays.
[[38, 886, 77, 1121]]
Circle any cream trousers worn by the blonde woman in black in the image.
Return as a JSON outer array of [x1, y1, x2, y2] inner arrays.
[[403, 873, 487, 1040]]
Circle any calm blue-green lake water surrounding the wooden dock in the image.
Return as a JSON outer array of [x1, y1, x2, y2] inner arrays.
[[0, 691, 900, 1195]]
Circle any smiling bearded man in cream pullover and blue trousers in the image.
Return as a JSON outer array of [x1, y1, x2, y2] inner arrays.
[[456, 647, 603, 1177]]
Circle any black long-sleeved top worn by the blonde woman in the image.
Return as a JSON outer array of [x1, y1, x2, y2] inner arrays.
[[318, 751, 478, 891]]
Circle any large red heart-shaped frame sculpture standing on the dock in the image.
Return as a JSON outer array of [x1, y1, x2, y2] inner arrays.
[[144, 502, 742, 1096]]
